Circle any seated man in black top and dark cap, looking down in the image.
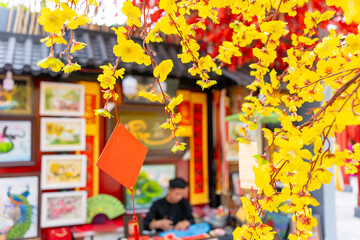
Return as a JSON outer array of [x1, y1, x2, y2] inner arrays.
[[144, 178, 194, 231]]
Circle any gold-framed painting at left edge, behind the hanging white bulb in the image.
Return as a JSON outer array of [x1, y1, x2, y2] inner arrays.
[[0, 72, 33, 115]]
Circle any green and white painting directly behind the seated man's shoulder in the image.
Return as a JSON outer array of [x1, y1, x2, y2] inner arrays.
[[125, 164, 176, 212]]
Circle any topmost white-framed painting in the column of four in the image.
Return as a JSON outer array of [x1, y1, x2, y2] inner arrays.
[[39, 82, 85, 117]]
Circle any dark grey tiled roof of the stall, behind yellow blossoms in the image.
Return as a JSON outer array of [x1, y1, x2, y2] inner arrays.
[[0, 29, 253, 86]]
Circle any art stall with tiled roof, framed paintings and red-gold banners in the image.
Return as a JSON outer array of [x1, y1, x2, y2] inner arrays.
[[0, 4, 296, 240]]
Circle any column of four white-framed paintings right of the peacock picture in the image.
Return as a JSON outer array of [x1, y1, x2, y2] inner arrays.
[[39, 82, 87, 228]]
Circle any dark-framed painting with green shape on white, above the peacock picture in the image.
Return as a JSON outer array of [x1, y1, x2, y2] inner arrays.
[[0, 117, 36, 167]]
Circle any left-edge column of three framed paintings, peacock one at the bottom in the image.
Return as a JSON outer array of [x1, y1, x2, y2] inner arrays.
[[0, 74, 40, 239]]
